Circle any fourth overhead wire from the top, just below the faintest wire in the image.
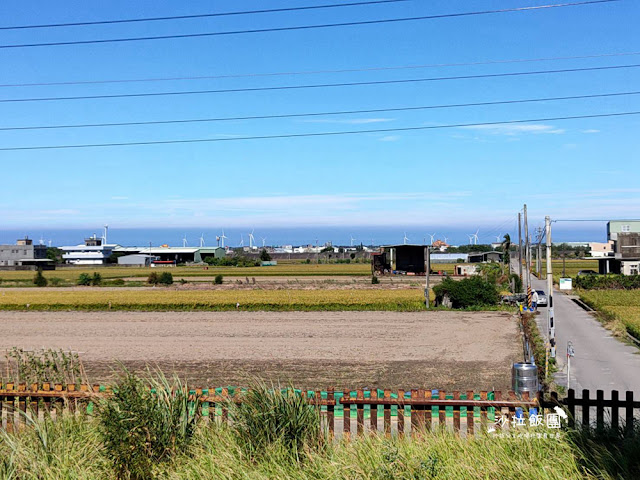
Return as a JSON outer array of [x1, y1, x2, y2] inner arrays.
[[0, 64, 640, 103]]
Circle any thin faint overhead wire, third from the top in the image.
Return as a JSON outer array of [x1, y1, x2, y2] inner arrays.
[[0, 52, 640, 88]]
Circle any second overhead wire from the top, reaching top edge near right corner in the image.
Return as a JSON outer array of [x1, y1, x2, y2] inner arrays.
[[0, 0, 620, 49]]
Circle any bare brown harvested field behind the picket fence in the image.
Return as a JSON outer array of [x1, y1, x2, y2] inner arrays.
[[0, 311, 521, 390]]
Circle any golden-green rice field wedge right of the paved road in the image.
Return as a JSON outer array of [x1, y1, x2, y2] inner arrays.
[[580, 290, 640, 339]]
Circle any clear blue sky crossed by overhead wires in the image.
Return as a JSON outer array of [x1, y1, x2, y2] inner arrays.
[[0, 0, 640, 242]]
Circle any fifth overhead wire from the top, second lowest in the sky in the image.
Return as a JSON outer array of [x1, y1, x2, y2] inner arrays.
[[0, 91, 640, 131]]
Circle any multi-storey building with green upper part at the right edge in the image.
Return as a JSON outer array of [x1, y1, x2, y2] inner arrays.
[[598, 220, 640, 275]]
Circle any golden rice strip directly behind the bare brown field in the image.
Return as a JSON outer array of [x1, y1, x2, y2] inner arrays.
[[0, 288, 424, 311]]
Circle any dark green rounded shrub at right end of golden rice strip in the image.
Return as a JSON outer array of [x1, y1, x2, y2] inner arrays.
[[433, 276, 500, 308]]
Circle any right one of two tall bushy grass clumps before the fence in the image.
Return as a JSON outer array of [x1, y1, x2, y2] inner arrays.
[[229, 382, 321, 459]]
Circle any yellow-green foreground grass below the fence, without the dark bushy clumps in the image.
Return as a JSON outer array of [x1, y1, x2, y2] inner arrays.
[[0, 417, 600, 480]]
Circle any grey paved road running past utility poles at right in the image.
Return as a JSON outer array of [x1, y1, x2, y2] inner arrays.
[[532, 278, 640, 398]]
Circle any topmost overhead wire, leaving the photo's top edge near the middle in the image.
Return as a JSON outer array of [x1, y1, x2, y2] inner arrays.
[[0, 0, 411, 30]]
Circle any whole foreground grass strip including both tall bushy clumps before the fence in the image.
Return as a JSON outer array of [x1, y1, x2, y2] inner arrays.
[[0, 371, 640, 480]]
